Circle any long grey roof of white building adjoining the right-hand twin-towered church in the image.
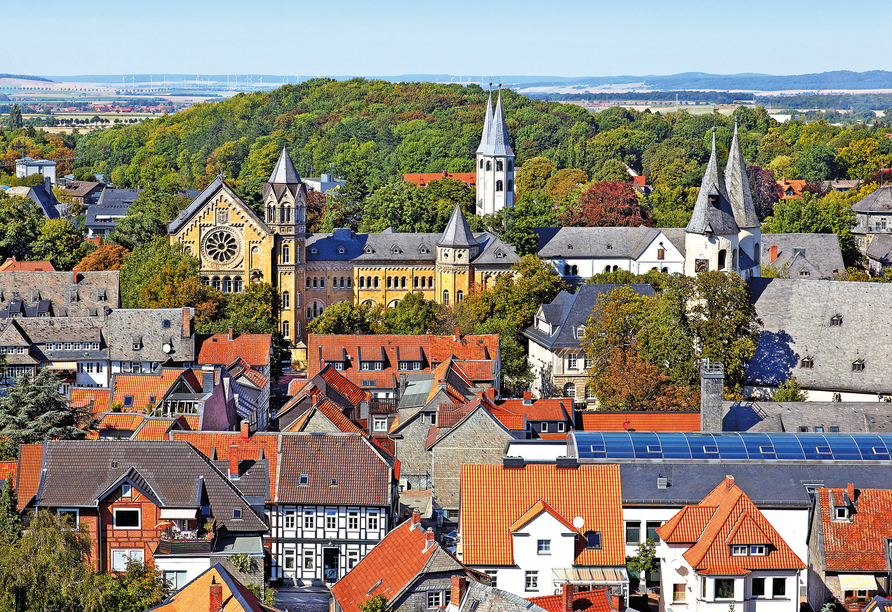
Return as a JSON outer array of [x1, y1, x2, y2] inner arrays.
[[533, 225, 668, 259]]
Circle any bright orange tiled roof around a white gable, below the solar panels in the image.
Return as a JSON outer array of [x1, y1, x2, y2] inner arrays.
[[461, 464, 626, 566]]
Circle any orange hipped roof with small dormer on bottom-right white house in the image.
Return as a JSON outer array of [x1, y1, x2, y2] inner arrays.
[[657, 477, 805, 575]]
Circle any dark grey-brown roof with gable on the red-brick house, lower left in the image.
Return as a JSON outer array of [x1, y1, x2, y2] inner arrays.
[[35, 440, 268, 533]]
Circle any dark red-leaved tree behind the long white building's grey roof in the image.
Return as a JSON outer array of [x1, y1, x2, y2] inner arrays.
[[559, 182, 653, 227]]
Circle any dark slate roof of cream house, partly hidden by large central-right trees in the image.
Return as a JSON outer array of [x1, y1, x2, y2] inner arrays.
[[523, 284, 654, 350]]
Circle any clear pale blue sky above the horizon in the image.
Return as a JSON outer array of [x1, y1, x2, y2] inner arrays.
[[6, 0, 892, 78]]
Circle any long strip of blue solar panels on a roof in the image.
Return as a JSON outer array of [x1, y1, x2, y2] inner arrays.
[[571, 431, 892, 461]]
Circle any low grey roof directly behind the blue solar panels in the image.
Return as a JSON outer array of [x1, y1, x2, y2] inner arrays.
[[722, 401, 892, 433]]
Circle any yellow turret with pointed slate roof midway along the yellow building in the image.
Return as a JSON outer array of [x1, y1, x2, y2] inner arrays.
[[437, 204, 480, 304]]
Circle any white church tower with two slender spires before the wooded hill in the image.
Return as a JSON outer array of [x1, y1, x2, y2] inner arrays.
[[477, 91, 514, 215]]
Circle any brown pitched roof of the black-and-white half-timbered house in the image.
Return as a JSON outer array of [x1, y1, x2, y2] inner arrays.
[[278, 433, 393, 506]]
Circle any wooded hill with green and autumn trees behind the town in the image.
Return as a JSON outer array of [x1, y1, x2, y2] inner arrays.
[[77, 79, 596, 187]]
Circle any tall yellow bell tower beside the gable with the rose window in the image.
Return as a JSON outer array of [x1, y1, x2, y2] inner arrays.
[[264, 147, 307, 350]]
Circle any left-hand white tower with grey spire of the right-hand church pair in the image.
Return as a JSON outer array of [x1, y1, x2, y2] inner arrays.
[[685, 128, 743, 276]]
